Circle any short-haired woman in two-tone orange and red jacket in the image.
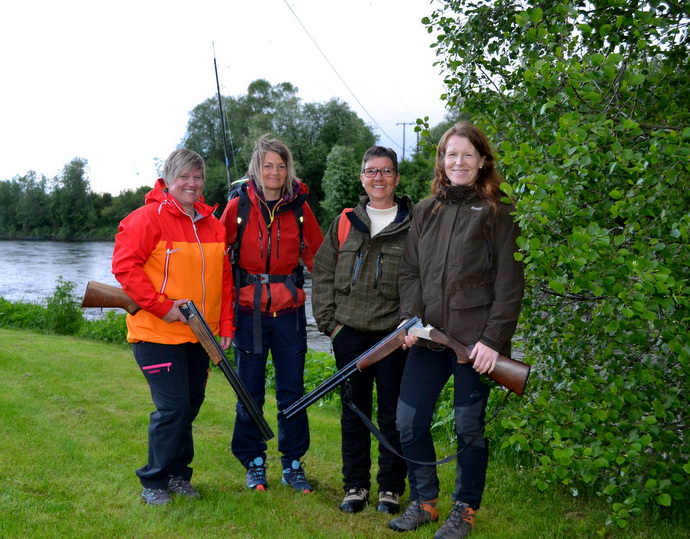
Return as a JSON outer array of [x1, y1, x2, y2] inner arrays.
[[112, 149, 233, 505]]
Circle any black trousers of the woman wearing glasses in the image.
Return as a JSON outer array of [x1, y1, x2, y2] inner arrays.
[[332, 326, 407, 494]]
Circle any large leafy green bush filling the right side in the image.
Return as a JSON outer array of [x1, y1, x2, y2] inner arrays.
[[425, 0, 690, 527]]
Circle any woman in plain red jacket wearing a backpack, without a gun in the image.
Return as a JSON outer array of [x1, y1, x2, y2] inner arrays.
[[221, 136, 323, 492]]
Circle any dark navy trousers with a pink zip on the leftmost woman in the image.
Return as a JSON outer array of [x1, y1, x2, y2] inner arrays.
[[133, 342, 209, 489]]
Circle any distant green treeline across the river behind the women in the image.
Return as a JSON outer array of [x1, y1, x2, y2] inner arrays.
[[0, 80, 440, 240]]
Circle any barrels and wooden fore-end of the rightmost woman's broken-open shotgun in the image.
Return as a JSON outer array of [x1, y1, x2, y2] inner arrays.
[[282, 316, 421, 419]]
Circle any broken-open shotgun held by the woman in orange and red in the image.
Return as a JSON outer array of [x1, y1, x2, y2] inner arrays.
[[81, 281, 275, 441]]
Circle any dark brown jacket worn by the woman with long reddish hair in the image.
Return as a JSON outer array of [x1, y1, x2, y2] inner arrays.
[[399, 186, 524, 355]]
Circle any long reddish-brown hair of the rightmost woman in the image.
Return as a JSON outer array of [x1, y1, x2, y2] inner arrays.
[[431, 122, 503, 211]]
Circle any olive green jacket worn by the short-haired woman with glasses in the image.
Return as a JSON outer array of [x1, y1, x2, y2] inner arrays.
[[312, 196, 414, 337]]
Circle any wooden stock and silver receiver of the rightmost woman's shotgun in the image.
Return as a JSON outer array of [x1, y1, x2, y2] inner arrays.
[[409, 326, 531, 396]]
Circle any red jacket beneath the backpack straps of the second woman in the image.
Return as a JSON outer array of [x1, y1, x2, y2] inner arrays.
[[220, 180, 323, 313]]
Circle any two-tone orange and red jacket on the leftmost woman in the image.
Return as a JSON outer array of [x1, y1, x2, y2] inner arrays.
[[112, 179, 234, 344]]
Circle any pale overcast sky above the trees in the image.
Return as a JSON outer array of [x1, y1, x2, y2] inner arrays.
[[0, 0, 445, 194]]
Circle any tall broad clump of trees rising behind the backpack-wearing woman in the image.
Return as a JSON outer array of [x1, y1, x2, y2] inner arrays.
[[183, 79, 376, 221]]
